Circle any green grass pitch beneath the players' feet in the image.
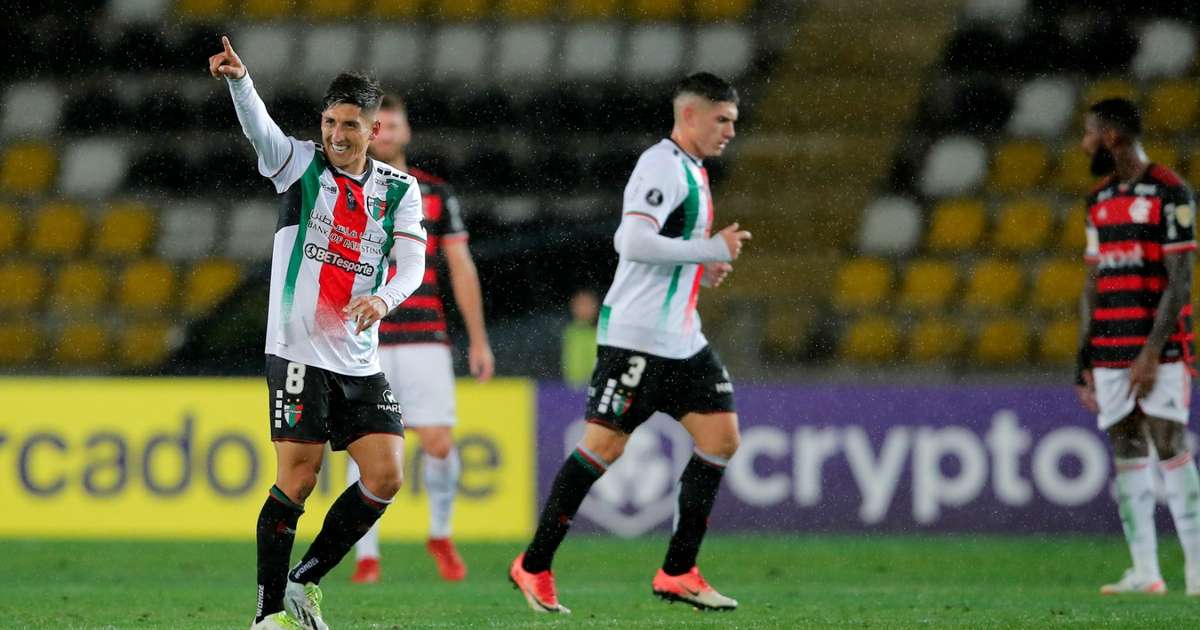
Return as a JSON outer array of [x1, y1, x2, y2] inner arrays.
[[0, 535, 1200, 630]]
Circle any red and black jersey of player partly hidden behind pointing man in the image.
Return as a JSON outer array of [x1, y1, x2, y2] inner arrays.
[[379, 168, 467, 344]]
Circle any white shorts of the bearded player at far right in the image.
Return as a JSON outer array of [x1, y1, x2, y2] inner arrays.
[[1092, 361, 1192, 430]]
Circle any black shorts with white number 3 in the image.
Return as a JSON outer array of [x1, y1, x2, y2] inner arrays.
[[587, 346, 734, 433]]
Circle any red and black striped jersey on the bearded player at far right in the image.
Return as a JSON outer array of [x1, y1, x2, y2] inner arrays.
[[1085, 164, 1196, 368]]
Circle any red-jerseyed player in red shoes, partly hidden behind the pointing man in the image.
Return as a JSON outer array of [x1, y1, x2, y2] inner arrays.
[[347, 95, 494, 583]]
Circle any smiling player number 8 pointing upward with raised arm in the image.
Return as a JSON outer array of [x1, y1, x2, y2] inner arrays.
[[209, 37, 425, 630]]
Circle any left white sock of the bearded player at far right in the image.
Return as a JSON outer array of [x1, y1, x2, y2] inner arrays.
[[1116, 457, 1162, 580]]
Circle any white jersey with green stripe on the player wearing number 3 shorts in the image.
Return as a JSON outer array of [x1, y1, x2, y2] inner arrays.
[[596, 139, 724, 359]]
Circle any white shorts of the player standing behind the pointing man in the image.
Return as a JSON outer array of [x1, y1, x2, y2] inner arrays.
[[379, 343, 458, 426]]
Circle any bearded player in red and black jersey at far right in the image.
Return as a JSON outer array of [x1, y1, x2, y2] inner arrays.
[[1078, 98, 1200, 595]]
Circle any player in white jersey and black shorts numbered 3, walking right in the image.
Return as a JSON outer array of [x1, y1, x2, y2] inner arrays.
[[509, 73, 750, 612]]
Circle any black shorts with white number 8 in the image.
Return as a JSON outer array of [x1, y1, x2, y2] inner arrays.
[[266, 354, 404, 451]]
